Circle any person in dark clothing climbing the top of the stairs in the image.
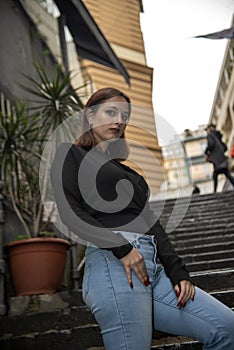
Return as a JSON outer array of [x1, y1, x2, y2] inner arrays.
[[205, 124, 234, 192]]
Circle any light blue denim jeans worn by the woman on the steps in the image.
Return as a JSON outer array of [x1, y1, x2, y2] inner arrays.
[[83, 236, 234, 350]]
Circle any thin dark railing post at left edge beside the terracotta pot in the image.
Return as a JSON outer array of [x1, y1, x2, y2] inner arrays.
[[0, 179, 6, 316]]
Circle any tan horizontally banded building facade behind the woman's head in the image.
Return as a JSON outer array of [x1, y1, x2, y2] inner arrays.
[[79, 0, 164, 194]]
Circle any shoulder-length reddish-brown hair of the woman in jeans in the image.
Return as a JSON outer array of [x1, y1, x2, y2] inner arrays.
[[75, 87, 131, 160]]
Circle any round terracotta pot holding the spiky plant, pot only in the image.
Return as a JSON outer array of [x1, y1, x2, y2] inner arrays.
[[6, 238, 70, 296]]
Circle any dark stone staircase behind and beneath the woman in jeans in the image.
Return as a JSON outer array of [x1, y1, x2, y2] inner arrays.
[[0, 191, 234, 350]]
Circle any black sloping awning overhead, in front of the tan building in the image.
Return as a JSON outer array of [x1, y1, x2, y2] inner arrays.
[[54, 0, 130, 85]]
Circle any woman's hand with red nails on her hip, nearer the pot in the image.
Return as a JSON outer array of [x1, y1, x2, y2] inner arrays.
[[120, 248, 150, 288]]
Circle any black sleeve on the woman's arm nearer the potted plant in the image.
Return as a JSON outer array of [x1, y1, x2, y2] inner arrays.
[[51, 143, 133, 259]]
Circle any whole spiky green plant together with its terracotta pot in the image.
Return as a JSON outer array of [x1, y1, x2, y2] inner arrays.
[[0, 65, 83, 296]]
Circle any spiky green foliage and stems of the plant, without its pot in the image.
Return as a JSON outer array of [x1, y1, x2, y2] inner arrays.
[[0, 65, 83, 237]]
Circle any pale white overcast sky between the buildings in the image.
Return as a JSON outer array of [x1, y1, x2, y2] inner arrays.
[[141, 0, 234, 136]]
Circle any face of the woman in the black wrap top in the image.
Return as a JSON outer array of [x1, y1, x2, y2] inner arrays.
[[87, 96, 130, 143]]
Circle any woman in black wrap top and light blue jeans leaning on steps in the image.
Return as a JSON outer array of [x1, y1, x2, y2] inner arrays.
[[51, 88, 234, 350]]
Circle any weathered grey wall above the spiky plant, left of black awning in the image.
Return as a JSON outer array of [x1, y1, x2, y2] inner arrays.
[[0, 0, 56, 100]]
